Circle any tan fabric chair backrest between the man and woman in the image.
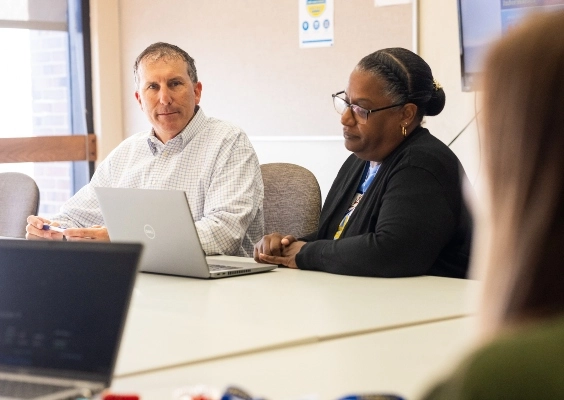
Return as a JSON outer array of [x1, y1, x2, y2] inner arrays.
[[260, 163, 321, 237]]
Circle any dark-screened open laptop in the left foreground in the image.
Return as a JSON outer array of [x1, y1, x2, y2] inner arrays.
[[0, 240, 142, 400]]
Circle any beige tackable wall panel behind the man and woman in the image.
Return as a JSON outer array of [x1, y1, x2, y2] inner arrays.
[[119, 0, 412, 136]]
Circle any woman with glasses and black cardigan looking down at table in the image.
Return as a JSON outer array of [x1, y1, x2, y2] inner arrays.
[[254, 48, 471, 278]]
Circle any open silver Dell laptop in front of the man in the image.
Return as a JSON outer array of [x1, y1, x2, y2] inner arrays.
[[94, 187, 276, 278]]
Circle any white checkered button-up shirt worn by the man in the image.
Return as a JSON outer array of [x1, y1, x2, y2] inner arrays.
[[52, 108, 264, 256]]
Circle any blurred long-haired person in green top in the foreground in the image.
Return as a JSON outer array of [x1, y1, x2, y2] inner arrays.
[[425, 11, 564, 400]]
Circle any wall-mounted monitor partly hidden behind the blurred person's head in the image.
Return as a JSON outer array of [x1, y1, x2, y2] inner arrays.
[[458, 0, 564, 91]]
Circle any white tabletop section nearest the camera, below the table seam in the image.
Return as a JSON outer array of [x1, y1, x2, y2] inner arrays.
[[112, 317, 475, 400]]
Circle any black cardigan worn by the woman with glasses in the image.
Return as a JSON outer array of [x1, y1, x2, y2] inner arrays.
[[296, 127, 472, 278]]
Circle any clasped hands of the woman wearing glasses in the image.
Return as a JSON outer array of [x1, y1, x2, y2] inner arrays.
[[254, 233, 306, 268]]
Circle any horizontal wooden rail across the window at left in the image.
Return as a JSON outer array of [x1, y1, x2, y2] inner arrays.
[[0, 133, 97, 163]]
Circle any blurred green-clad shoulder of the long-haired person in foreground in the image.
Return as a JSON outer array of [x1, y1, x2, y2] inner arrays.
[[428, 317, 564, 399]]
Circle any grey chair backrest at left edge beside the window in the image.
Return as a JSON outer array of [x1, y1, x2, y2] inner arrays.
[[0, 172, 39, 238]]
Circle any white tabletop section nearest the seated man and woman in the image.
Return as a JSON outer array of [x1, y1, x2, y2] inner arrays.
[[114, 260, 479, 377]]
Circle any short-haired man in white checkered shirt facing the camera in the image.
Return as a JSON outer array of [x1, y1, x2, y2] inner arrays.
[[26, 43, 263, 256]]
